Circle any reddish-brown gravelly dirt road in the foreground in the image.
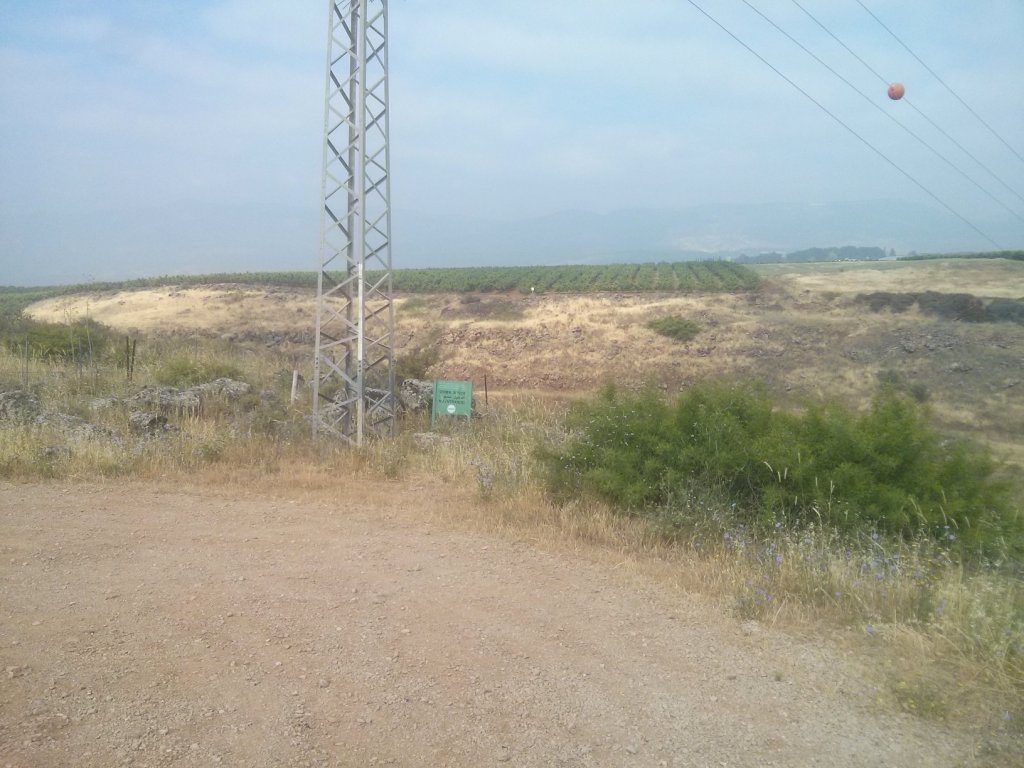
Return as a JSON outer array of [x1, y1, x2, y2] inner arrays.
[[0, 484, 970, 768]]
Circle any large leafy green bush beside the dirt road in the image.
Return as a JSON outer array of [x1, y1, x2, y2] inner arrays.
[[542, 385, 1022, 550]]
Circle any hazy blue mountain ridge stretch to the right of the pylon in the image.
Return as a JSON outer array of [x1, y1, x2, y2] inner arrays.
[[395, 201, 1024, 265]]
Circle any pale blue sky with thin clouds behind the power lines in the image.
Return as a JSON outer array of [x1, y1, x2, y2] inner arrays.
[[0, 0, 1024, 284]]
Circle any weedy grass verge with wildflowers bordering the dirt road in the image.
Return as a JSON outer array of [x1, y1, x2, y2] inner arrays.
[[0, 317, 1024, 765]]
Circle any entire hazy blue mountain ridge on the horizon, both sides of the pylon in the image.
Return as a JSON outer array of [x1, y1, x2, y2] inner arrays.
[[0, 201, 1024, 285]]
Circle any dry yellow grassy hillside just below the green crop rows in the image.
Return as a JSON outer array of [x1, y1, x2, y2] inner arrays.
[[19, 260, 1024, 463]]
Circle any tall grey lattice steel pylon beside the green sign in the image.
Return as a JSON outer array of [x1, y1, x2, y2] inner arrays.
[[312, 0, 397, 445]]
